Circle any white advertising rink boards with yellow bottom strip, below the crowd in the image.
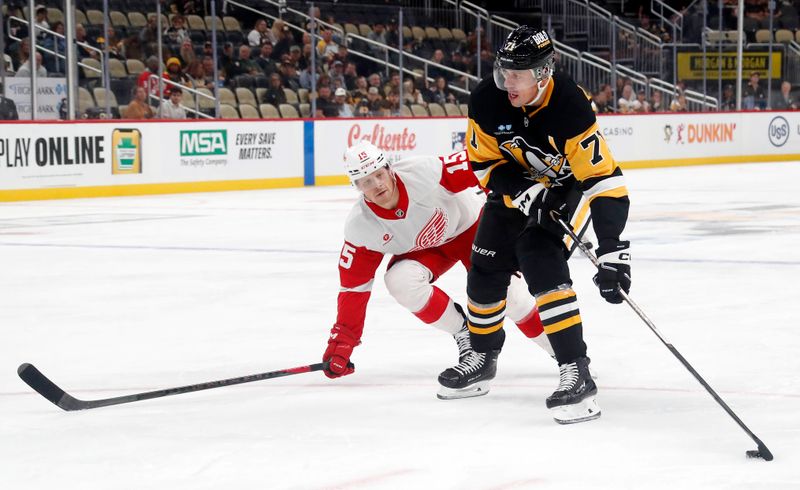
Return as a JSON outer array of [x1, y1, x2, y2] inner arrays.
[[0, 112, 800, 201]]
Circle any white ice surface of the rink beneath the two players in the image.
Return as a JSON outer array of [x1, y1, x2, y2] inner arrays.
[[0, 163, 800, 490]]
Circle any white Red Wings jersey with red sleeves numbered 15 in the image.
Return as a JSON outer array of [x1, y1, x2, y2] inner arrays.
[[336, 151, 485, 338]]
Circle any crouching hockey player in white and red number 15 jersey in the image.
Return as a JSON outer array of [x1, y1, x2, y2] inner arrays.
[[323, 142, 552, 399]]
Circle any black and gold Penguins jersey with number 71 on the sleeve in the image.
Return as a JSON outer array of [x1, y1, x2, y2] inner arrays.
[[467, 74, 629, 245]]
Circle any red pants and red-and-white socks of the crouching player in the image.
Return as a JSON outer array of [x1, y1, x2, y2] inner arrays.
[[384, 218, 542, 338]]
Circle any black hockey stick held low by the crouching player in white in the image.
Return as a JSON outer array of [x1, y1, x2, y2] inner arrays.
[[17, 362, 338, 412]]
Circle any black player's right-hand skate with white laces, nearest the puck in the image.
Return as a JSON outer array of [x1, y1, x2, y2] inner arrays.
[[547, 357, 600, 424]]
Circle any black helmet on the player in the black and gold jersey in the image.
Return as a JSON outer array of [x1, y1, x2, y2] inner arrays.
[[495, 26, 555, 89]]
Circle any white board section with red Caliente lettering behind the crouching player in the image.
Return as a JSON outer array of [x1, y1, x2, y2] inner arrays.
[[314, 118, 467, 184]]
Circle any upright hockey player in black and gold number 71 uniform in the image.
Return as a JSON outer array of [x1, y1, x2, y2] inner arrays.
[[467, 26, 631, 423]]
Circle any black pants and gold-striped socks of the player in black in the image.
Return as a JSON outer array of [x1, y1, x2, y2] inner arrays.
[[467, 197, 586, 364]]
